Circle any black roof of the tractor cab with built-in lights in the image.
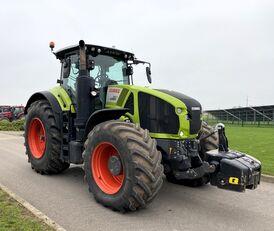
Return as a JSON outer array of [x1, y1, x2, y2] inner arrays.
[[55, 44, 135, 60]]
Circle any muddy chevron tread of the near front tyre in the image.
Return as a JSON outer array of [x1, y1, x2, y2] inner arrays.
[[83, 121, 163, 211]]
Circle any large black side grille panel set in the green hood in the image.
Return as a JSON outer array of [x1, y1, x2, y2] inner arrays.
[[138, 92, 179, 134]]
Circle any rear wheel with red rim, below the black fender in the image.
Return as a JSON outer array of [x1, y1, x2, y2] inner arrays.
[[24, 100, 69, 174]]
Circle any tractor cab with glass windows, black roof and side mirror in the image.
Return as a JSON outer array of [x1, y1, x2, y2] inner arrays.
[[55, 44, 151, 109]]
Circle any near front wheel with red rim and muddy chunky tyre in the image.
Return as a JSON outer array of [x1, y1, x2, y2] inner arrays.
[[84, 121, 163, 212]]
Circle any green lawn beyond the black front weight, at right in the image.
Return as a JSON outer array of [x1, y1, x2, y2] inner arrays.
[[226, 125, 274, 175]]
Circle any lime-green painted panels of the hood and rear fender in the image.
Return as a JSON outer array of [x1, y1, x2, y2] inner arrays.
[[50, 85, 197, 139]]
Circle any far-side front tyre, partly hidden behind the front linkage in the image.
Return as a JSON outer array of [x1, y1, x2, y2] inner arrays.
[[166, 121, 219, 187]]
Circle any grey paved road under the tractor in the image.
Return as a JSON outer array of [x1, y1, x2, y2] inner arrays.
[[0, 133, 274, 231]]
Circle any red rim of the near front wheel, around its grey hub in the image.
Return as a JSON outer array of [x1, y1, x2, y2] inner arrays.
[[91, 142, 125, 194]]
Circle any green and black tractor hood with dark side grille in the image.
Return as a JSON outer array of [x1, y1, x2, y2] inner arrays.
[[105, 85, 201, 139]]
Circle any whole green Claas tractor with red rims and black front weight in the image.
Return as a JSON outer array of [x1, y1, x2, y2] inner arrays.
[[24, 40, 261, 211]]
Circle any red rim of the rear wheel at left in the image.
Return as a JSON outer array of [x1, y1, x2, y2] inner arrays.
[[28, 118, 46, 159]]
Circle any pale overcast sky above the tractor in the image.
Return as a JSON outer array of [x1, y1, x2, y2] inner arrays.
[[0, 0, 274, 109]]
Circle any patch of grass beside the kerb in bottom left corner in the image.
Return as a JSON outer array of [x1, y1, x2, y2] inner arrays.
[[0, 189, 53, 231]]
